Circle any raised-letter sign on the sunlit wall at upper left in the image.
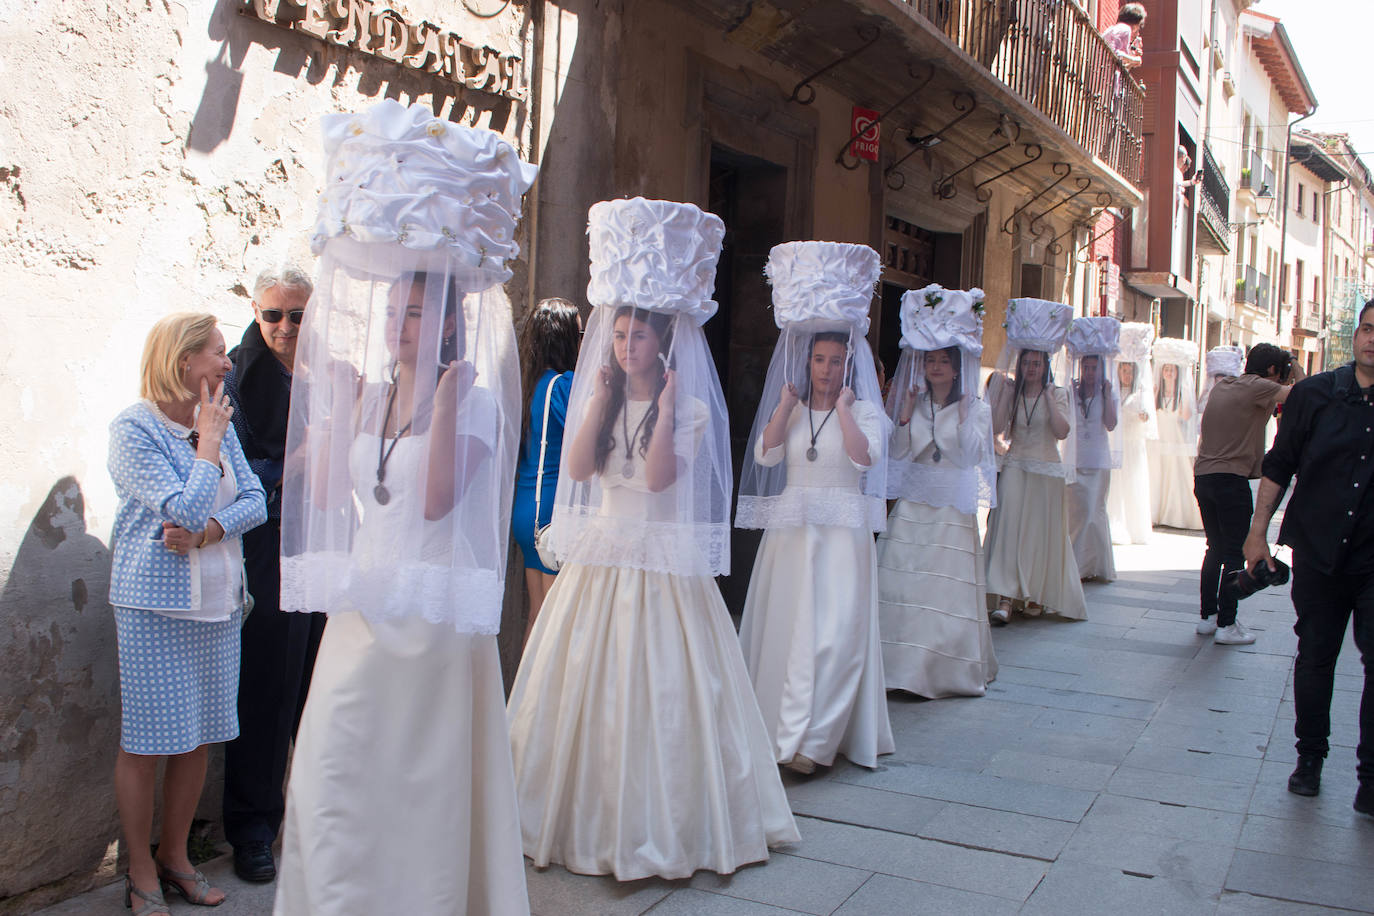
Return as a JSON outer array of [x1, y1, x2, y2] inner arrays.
[[242, 0, 525, 102]]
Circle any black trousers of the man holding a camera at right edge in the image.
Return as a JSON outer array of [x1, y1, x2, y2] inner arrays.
[[1292, 552, 1374, 786]]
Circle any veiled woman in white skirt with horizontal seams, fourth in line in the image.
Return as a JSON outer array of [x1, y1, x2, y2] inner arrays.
[[878, 286, 998, 698]]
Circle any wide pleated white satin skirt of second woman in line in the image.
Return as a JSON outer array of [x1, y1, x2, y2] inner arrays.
[[510, 563, 798, 880]]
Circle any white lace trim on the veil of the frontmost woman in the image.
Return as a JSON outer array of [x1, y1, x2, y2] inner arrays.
[[282, 552, 506, 636]]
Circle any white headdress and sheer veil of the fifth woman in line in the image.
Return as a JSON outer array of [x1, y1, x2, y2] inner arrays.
[[984, 298, 1077, 482]]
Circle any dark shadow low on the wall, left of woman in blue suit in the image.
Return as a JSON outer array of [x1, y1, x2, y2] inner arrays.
[[0, 477, 120, 912]]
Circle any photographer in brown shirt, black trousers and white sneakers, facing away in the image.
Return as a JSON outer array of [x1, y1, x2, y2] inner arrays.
[[1193, 343, 1303, 645]]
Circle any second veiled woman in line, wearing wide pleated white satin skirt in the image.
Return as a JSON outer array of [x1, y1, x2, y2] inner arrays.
[[508, 198, 798, 880]]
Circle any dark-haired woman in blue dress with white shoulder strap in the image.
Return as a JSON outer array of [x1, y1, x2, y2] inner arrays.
[[511, 298, 583, 640]]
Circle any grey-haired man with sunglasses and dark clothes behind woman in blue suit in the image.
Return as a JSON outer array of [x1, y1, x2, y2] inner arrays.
[[224, 266, 324, 882]]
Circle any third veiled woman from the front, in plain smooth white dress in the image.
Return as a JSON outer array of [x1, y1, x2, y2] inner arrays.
[[735, 242, 894, 773]]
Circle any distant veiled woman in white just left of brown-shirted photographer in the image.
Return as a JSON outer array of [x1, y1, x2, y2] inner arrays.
[[1147, 338, 1202, 531]]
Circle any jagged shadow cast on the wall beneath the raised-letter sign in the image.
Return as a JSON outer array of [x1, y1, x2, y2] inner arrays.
[[196, 0, 528, 152]]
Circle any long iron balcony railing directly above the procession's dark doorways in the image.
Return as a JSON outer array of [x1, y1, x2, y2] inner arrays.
[[900, 0, 1145, 184]]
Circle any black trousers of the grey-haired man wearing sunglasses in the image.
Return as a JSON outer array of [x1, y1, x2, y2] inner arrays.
[[224, 519, 324, 846]]
